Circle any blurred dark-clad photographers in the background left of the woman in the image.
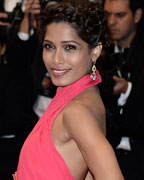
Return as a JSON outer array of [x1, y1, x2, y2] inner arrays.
[[0, 0, 56, 179]]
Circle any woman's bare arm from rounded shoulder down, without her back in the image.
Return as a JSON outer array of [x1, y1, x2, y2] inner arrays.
[[64, 103, 123, 180]]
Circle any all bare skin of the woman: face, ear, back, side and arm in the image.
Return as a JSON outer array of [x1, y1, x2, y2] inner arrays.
[[43, 22, 123, 180]]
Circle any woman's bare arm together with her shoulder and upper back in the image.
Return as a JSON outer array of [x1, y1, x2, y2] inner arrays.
[[63, 88, 123, 180]]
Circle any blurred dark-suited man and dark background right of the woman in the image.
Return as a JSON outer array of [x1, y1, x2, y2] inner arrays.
[[99, 0, 144, 180]]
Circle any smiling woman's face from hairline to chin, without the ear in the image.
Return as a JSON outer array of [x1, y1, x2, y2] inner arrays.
[[43, 22, 92, 87]]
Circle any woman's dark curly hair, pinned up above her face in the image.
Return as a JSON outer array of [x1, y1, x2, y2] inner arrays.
[[38, 2, 109, 49]]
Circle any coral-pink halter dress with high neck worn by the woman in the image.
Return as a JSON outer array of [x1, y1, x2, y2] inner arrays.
[[13, 72, 101, 180]]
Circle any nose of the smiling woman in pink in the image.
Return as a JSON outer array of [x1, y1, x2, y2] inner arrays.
[[53, 49, 65, 64]]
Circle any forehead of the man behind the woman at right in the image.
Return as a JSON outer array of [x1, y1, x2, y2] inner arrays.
[[104, 0, 130, 13]]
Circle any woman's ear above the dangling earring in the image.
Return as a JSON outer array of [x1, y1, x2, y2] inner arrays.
[[91, 42, 102, 62]]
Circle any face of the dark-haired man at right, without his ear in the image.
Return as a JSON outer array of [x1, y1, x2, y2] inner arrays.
[[104, 0, 137, 48]]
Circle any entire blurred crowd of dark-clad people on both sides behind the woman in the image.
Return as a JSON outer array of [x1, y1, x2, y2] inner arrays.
[[0, 0, 144, 180]]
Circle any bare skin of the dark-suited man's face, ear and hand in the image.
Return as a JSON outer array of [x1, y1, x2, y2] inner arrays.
[[104, 0, 142, 95]]
